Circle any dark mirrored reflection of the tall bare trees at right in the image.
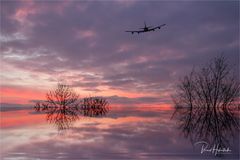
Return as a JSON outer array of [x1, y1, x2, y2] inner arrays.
[[173, 106, 239, 147]]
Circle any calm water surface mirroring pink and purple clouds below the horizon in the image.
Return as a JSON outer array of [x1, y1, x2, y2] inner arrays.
[[1, 107, 239, 160]]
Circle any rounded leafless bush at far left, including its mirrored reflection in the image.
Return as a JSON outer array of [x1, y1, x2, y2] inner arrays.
[[35, 84, 80, 130]]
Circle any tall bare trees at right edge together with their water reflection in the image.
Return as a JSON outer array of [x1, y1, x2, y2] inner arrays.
[[173, 56, 240, 149]]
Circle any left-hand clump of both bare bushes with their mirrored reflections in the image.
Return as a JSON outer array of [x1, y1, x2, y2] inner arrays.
[[34, 84, 109, 131]]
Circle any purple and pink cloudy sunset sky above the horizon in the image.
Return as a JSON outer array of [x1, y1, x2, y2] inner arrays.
[[0, 0, 239, 106]]
